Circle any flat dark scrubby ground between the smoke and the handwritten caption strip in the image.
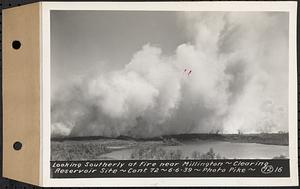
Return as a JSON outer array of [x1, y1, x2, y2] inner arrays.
[[51, 133, 288, 161]]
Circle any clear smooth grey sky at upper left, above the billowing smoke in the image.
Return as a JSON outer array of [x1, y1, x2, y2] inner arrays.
[[51, 11, 188, 93]]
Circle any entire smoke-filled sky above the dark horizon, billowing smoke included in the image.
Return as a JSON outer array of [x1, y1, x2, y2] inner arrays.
[[51, 11, 289, 137]]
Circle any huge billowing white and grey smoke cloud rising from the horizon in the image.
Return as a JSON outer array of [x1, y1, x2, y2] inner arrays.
[[51, 12, 288, 137]]
